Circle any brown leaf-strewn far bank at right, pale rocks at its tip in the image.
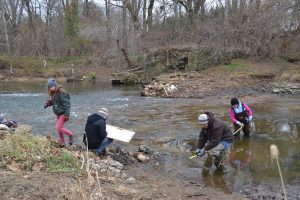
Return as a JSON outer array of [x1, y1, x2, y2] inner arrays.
[[142, 60, 300, 98]]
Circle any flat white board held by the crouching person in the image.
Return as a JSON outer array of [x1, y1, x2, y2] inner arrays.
[[106, 124, 135, 142]]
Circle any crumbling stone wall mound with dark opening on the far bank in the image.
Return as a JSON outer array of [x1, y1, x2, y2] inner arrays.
[[112, 46, 248, 84]]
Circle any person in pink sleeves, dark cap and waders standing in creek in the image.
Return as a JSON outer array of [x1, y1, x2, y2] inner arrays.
[[228, 97, 252, 137]]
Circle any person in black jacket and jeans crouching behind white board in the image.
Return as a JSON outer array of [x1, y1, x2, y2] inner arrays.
[[83, 108, 113, 156]]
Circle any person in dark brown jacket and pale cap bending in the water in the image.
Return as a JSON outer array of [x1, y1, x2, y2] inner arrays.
[[196, 112, 233, 174]]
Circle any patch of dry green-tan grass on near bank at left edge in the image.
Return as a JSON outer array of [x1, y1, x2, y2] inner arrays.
[[0, 133, 79, 172]]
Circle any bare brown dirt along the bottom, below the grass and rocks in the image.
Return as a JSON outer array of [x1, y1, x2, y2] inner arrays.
[[0, 163, 244, 200]]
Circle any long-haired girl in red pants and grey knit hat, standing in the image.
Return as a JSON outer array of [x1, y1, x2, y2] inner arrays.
[[44, 78, 75, 147]]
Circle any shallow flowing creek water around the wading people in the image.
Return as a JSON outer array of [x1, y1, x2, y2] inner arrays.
[[0, 81, 300, 199]]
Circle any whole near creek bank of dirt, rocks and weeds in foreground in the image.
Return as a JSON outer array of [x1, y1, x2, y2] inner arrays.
[[0, 125, 243, 200]]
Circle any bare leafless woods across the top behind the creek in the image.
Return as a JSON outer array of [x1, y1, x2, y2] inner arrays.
[[0, 0, 300, 64]]
